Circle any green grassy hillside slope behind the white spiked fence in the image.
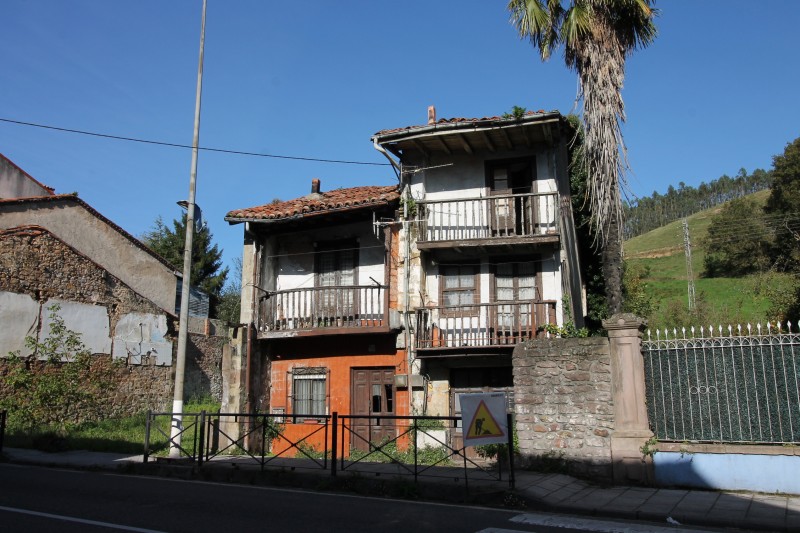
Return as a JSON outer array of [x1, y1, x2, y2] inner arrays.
[[625, 191, 793, 329]]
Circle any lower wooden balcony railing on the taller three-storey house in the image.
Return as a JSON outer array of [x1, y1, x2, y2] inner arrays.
[[415, 300, 556, 350]]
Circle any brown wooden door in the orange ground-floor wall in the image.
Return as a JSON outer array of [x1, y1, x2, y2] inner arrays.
[[350, 367, 396, 451]]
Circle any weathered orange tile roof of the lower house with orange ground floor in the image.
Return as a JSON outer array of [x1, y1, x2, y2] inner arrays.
[[225, 185, 400, 222]]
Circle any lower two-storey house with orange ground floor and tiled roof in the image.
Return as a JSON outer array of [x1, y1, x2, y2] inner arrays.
[[225, 179, 409, 449]]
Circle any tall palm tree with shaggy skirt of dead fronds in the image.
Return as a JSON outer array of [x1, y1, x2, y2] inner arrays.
[[508, 0, 658, 314]]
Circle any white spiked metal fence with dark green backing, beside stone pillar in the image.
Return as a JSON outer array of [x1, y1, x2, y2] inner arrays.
[[642, 325, 800, 444]]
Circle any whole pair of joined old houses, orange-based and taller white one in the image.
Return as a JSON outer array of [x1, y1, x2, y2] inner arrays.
[[226, 109, 585, 449]]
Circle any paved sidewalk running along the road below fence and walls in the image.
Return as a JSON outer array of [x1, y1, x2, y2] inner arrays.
[[3, 448, 800, 532]]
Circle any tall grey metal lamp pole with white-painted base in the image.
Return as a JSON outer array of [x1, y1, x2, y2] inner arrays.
[[169, 0, 206, 457]]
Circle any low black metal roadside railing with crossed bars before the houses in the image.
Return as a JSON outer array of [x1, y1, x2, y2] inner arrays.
[[143, 411, 514, 488]]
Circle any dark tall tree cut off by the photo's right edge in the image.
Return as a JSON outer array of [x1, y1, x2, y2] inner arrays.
[[764, 138, 800, 274]]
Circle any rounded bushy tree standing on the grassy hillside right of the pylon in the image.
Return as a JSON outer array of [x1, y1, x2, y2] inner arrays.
[[703, 197, 770, 278]]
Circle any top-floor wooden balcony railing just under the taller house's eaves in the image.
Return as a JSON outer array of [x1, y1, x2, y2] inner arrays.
[[419, 193, 560, 242]]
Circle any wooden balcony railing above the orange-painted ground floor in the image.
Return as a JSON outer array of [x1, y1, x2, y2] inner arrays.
[[258, 285, 391, 338]]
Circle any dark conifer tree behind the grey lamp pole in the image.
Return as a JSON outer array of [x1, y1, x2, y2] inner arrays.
[[141, 213, 228, 317]]
